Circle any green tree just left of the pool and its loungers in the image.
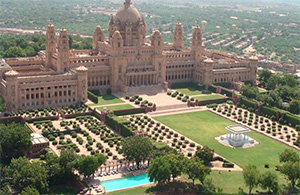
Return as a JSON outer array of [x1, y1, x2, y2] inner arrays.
[[76, 154, 106, 178]]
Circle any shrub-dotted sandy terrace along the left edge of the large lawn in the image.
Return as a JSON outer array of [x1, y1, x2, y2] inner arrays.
[[120, 115, 239, 169]]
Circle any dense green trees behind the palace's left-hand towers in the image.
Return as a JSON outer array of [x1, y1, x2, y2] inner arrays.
[[0, 34, 92, 58]]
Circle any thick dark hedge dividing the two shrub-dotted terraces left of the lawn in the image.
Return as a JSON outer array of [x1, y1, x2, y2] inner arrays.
[[105, 115, 132, 137]]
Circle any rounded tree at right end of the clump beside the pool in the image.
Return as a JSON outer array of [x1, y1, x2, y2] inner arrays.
[[186, 157, 211, 184]]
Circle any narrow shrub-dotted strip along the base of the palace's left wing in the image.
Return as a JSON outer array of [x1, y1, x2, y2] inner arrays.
[[6, 107, 58, 119]]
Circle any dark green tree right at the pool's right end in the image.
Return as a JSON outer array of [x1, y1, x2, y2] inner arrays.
[[148, 156, 172, 183]]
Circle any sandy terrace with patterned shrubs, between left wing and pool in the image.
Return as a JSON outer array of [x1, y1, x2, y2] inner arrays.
[[29, 115, 123, 160]]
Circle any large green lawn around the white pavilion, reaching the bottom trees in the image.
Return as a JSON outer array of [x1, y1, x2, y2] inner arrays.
[[154, 111, 296, 193]]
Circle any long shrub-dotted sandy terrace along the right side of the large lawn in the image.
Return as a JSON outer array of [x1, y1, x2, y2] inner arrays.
[[208, 104, 300, 150]]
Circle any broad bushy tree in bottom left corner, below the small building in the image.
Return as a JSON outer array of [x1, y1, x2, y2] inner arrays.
[[8, 157, 48, 193]]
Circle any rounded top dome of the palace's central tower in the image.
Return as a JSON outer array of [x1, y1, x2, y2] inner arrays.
[[116, 0, 141, 24]]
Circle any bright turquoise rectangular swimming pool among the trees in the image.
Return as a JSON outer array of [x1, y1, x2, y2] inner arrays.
[[101, 173, 151, 192]]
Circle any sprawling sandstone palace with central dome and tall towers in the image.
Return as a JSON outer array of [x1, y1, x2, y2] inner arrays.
[[0, 0, 257, 110]]
